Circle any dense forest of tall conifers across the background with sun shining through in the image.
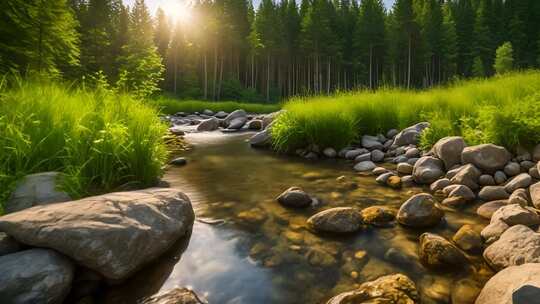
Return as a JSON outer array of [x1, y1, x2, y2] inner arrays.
[[0, 0, 540, 102]]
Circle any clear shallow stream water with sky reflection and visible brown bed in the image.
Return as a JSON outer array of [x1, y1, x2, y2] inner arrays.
[[105, 132, 493, 304]]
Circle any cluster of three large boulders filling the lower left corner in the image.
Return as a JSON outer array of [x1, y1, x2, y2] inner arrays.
[[0, 172, 194, 304]]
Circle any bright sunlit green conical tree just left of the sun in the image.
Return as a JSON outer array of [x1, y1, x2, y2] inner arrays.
[[120, 0, 163, 96]]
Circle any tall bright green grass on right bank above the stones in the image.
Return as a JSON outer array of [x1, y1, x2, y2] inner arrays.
[[272, 71, 540, 150]]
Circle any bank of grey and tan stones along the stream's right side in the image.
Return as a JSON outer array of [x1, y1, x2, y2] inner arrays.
[[244, 108, 540, 304]]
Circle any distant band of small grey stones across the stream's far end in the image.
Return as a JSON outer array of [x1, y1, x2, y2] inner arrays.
[[163, 109, 274, 135]]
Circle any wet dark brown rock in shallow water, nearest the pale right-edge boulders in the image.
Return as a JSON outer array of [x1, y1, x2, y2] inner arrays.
[[419, 232, 467, 268]]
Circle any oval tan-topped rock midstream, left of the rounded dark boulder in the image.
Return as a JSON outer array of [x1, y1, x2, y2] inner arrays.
[[307, 207, 362, 233]]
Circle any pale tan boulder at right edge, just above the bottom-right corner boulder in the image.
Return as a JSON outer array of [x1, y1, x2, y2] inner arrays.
[[484, 225, 540, 270]]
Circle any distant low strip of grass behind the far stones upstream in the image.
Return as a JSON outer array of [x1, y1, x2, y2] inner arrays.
[[150, 96, 281, 114]]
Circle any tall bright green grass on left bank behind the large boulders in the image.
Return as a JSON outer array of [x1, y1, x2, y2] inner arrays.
[[0, 80, 166, 208]]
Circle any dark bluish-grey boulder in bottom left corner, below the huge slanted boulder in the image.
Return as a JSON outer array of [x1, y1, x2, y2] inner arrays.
[[0, 249, 74, 304]]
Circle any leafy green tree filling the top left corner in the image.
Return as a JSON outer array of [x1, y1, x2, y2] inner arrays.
[[0, 0, 79, 74]]
